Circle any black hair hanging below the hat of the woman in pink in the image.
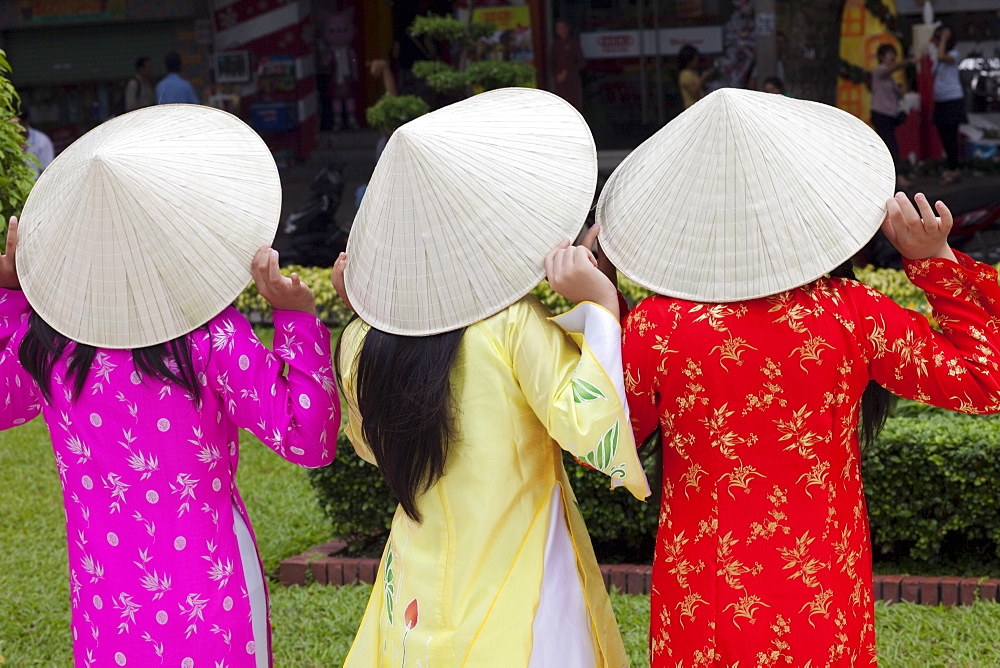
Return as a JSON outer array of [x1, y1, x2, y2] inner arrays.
[[17, 312, 198, 403]]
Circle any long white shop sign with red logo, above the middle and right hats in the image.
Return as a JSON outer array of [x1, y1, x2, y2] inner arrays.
[[580, 26, 722, 60]]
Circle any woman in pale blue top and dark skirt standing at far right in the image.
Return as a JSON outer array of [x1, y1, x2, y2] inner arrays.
[[931, 26, 969, 185]]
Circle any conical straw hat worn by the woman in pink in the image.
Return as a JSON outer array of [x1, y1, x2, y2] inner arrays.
[[17, 104, 281, 348]]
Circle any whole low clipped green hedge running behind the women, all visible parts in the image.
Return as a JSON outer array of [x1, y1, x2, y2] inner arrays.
[[309, 412, 1000, 562]]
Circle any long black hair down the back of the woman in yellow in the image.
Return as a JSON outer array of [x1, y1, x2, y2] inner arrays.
[[334, 325, 465, 522]]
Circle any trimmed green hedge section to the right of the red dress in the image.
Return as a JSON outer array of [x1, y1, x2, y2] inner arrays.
[[863, 407, 1000, 560]]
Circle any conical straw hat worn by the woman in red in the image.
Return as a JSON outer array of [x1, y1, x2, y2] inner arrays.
[[597, 88, 895, 302]]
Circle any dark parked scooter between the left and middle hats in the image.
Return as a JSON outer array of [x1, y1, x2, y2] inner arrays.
[[281, 163, 351, 267]]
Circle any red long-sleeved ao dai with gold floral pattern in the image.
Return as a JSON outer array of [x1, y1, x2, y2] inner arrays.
[[623, 253, 1000, 667]]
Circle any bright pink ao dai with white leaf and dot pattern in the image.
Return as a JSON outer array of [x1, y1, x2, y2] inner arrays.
[[0, 290, 340, 668]]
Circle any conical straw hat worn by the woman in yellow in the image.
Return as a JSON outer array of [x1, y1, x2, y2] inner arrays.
[[345, 88, 597, 336]]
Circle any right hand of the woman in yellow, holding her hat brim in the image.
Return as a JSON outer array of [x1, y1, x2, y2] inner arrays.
[[545, 225, 620, 318]]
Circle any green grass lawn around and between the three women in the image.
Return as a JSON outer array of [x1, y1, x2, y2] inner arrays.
[[0, 420, 1000, 667]]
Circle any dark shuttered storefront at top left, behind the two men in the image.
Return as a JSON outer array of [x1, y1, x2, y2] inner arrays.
[[0, 0, 211, 152]]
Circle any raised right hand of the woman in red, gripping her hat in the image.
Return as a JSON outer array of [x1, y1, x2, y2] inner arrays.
[[882, 193, 958, 262]]
